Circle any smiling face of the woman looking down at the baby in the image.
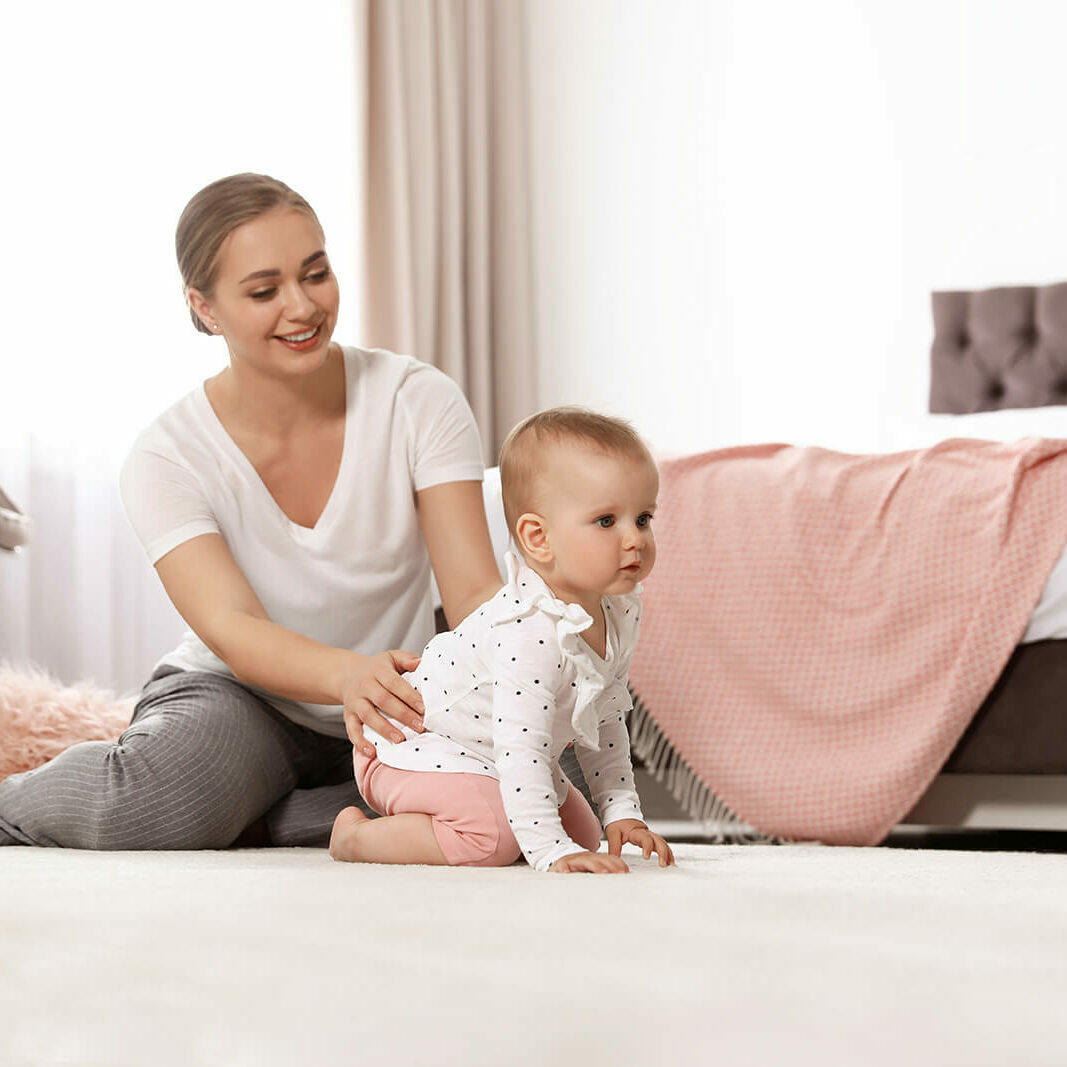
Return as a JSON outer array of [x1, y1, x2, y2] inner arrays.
[[190, 208, 339, 376]]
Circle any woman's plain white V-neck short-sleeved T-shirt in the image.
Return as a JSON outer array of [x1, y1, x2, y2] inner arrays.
[[120, 348, 482, 737]]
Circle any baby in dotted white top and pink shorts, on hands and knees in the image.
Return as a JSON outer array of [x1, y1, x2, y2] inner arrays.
[[330, 408, 674, 873]]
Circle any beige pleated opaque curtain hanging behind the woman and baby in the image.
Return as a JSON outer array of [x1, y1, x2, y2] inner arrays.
[[363, 0, 537, 463]]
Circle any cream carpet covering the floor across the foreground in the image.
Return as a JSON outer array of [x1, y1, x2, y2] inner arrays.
[[0, 845, 1067, 1067]]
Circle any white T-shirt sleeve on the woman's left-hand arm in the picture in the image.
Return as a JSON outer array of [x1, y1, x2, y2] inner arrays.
[[118, 442, 219, 564]]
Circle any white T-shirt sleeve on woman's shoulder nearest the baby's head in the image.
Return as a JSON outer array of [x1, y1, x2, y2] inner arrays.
[[397, 363, 484, 492]]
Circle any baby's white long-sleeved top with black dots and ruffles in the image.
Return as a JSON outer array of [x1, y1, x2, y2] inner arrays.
[[364, 553, 641, 871]]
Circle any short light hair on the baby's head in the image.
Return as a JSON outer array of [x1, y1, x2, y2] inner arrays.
[[499, 407, 654, 535]]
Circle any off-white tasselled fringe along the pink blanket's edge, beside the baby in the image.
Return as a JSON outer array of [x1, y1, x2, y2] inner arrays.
[[630, 689, 784, 845]]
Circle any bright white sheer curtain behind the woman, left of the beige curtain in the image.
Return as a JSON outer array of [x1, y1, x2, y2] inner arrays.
[[0, 0, 366, 691]]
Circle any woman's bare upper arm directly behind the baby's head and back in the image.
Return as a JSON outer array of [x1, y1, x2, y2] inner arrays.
[[415, 481, 504, 628]]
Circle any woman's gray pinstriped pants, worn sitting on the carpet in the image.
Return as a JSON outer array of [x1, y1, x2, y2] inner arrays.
[[0, 668, 595, 849]]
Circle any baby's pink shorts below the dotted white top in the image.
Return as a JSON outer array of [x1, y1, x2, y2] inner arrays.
[[353, 752, 601, 866]]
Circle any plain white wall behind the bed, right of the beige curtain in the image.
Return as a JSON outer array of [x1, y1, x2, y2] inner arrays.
[[528, 0, 1067, 452]]
